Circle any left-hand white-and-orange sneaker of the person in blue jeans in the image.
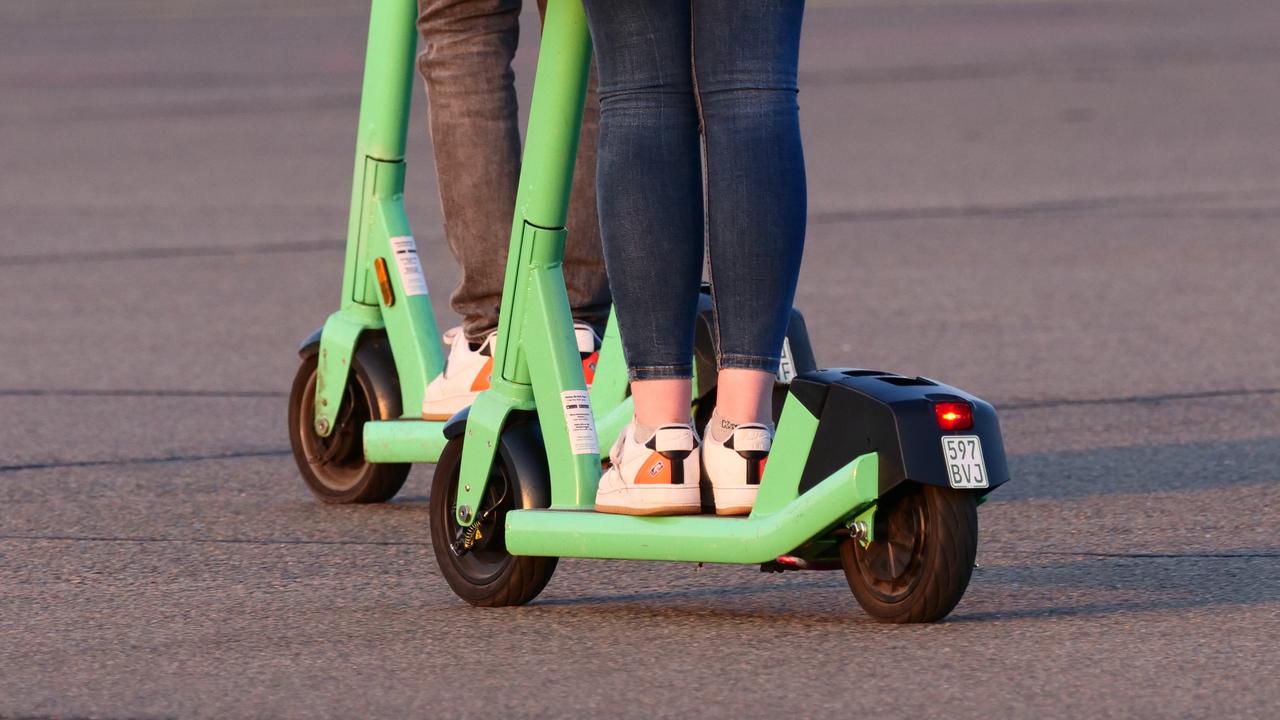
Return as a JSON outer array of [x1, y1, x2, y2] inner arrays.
[[595, 423, 701, 515]]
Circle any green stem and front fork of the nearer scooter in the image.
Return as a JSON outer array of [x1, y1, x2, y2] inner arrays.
[[456, 0, 600, 517]]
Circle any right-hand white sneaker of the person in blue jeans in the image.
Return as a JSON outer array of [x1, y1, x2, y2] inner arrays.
[[703, 423, 773, 515]]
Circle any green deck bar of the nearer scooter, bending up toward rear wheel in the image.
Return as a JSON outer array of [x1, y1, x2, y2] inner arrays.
[[506, 452, 879, 564]]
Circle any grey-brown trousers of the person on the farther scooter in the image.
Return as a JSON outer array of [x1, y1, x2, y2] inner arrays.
[[417, 0, 609, 340]]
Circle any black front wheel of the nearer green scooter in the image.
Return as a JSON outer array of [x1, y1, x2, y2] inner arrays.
[[430, 425, 558, 607]]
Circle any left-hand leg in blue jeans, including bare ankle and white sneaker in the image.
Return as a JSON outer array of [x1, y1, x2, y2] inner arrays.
[[585, 0, 703, 515]]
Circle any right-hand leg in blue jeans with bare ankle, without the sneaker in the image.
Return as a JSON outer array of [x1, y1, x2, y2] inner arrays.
[[692, 0, 806, 424]]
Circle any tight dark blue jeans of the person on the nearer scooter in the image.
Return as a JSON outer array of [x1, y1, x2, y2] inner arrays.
[[584, 0, 806, 380]]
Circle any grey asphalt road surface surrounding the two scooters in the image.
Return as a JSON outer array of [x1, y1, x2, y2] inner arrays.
[[0, 0, 1280, 719]]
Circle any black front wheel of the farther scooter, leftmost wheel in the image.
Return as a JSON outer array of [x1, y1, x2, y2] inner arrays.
[[289, 341, 411, 505]]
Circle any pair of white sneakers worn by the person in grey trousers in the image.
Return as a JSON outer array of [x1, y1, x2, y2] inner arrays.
[[422, 323, 600, 420]]
